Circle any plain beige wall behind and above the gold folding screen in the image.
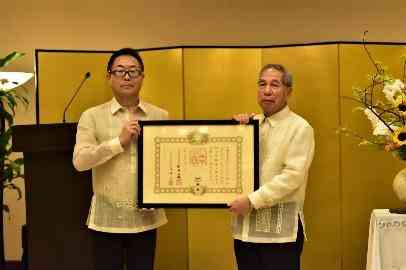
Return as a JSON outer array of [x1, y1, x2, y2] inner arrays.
[[0, 0, 406, 269]]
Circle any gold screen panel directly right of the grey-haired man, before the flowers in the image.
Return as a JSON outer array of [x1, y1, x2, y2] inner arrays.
[[262, 45, 341, 270]]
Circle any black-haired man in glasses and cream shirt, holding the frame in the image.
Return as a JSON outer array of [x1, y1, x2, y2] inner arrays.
[[73, 48, 168, 270]]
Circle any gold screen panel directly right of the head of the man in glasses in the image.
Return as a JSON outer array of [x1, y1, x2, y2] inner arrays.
[[140, 49, 188, 270]]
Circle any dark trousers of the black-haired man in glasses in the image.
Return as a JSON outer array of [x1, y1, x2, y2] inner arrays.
[[91, 230, 156, 270]]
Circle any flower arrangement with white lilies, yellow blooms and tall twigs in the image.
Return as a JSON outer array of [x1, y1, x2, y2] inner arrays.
[[340, 31, 406, 160]]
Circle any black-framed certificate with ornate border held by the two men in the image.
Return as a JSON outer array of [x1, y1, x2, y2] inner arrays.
[[137, 120, 259, 208]]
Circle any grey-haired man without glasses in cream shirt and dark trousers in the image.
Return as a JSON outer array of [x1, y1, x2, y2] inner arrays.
[[229, 64, 314, 270]]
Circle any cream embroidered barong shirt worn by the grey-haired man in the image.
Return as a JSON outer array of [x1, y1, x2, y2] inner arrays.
[[232, 106, 315, 243]]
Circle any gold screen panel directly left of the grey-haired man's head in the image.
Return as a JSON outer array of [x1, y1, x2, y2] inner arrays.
[[184, 49, 260, 270]]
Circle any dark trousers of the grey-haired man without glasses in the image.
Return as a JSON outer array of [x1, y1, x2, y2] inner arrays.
[[234, 221, 304, 270]]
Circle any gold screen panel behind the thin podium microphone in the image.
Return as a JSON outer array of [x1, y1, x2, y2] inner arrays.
[[37, 51, 112, 124]]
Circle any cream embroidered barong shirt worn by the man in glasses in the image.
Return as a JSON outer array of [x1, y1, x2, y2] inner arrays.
[[73, 98, 168, 233]]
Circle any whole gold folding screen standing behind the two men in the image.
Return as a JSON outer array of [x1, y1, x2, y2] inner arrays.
[[38, 44, 406, 270]]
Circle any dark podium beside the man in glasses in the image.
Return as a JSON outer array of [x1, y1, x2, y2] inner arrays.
[[12, 123, 93, 270]]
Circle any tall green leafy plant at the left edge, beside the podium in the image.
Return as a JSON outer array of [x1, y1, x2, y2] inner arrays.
[[0, 52, 28, 212]]
